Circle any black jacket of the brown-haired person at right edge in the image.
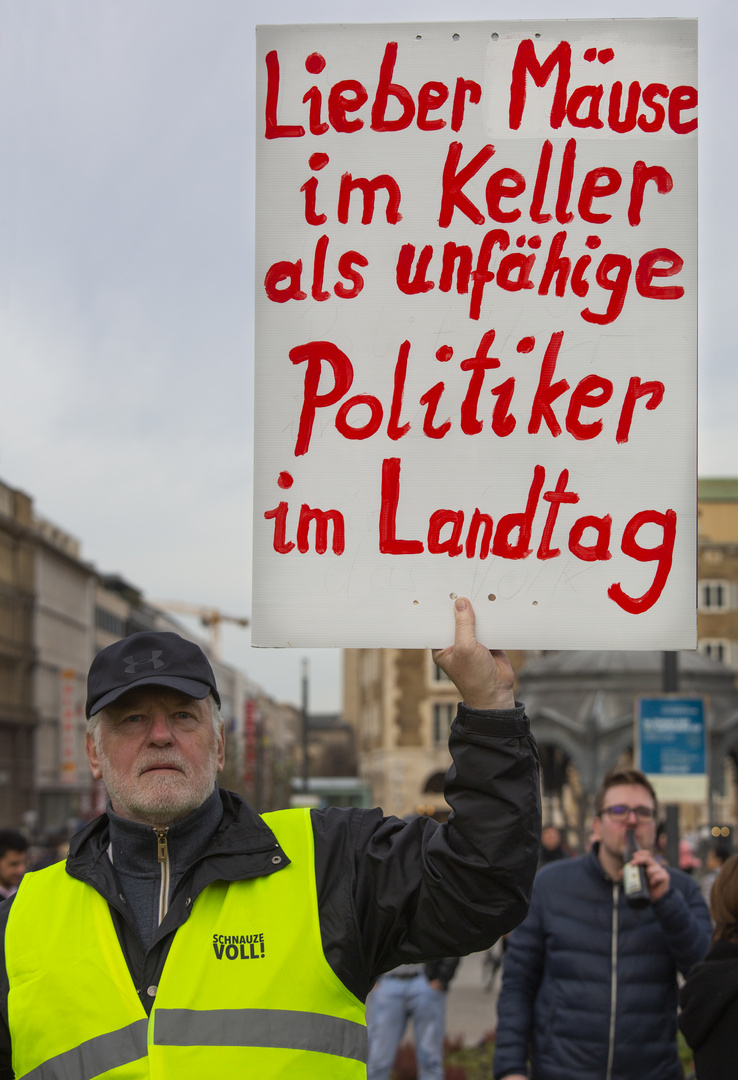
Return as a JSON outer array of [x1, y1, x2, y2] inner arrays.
[[679, 942, 738, 1080]]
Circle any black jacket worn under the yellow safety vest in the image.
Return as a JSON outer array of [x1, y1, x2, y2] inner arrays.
[[0, 705, 540, 1080]]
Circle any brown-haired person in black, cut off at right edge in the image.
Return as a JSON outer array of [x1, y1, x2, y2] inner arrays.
[[679, 855, 738, 1080]]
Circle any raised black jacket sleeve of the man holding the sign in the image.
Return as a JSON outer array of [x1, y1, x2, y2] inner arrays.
[[312, 705, 540, 1000]]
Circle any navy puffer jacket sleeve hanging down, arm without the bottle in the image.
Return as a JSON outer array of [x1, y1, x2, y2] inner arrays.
[[494, 888, 546, 1080]]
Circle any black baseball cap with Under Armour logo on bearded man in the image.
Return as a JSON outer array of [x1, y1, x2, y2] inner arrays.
[[85, 630, 220, 718]]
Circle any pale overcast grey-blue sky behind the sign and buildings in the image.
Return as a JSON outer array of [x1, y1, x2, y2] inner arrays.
[[0, 0, 738, 711]]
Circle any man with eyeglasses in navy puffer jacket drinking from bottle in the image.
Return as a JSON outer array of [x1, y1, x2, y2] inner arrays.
[[494, 767, 711, 1080]]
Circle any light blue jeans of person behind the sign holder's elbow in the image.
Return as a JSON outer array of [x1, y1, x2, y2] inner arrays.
[[366, 974, 446, 1080]]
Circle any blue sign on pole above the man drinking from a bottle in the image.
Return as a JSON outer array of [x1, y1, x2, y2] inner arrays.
[[638, 697, 708, 777]]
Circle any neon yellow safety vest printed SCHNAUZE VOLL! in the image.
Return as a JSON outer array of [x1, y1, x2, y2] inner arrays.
[[5, 810, 366, 1080]]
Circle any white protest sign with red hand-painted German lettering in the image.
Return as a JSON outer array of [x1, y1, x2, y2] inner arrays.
[[253, 19, 697, 649]]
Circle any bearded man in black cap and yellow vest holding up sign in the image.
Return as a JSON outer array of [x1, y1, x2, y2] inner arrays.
[[0, 600, 540, 1080]]
